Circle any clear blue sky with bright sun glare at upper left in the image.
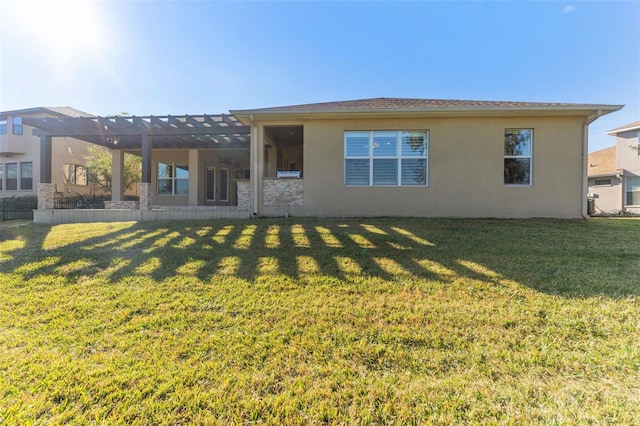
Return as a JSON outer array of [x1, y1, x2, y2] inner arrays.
[[0, 0, 640, 152]]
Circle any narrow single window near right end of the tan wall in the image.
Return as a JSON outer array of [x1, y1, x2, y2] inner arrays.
[[504, 129, 533, 185]]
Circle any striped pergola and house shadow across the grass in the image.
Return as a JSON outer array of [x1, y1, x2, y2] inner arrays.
[[0, 218, 640, 297]]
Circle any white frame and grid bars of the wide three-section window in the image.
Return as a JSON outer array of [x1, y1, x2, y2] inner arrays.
[[343, 129, 429, 188]]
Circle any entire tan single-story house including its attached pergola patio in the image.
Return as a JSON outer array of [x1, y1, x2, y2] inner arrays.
[[30, 98, 622, 221]]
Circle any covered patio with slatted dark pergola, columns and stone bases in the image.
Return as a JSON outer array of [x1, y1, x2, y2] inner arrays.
[[25, 114, 251, 223]]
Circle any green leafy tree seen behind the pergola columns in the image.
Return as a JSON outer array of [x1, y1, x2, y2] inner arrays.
[[85, 146, 142, 193]]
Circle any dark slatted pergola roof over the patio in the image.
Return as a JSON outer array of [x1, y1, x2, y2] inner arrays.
[[23, 114, 251, 150]]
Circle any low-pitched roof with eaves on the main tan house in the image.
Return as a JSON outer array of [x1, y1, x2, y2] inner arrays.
[[230, 98, 623, 120]]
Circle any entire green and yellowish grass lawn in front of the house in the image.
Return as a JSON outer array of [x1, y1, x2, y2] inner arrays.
[[0, 218, 640, 425]]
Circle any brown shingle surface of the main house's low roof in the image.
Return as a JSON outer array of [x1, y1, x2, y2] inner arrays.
[[231, 98, 621, 114]]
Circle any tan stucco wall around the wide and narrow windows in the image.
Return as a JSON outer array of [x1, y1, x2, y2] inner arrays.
[[258, 117, 584, 218]]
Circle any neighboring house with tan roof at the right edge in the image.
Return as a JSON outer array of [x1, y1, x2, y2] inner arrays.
[[588, 121, 640, 214]]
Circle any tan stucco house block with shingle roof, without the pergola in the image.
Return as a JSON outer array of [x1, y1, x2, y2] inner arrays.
[[230, 98, 622, 218]]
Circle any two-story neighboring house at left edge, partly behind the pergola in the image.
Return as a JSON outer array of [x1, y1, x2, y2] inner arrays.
[[0, 107, 99, 198]]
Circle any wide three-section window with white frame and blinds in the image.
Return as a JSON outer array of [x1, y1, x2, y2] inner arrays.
[[344, 130, 428, 186]]
